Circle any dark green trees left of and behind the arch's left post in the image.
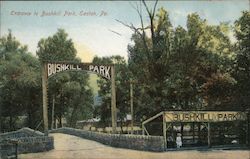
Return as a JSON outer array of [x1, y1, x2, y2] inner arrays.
[[0, 29, 93, 131]]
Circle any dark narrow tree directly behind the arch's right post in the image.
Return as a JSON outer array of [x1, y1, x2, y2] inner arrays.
[[93, 56, 130, 130]]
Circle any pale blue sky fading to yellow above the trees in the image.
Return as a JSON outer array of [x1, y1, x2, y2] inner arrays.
[[0, 0, 249, 62]]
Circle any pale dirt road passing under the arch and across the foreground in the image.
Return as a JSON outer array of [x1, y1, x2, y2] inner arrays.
[[18, 133, 250, 159]]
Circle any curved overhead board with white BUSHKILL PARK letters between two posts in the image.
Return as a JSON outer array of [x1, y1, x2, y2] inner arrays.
[[47, 62, 113, 80]]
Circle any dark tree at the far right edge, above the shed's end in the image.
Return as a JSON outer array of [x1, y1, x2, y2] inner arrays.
[[234, 11, 250, 110]]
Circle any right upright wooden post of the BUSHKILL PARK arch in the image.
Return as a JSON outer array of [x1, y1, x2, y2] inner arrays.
[[111, 66, 117, 133]]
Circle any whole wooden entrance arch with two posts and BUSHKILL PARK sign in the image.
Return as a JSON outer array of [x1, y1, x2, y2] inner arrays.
[[42, 62, 117, 135]]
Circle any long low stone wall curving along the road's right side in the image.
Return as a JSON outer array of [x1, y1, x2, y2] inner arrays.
[[50, 127, 164, 151]]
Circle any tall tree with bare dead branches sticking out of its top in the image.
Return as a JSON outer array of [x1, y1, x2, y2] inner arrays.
[[128, 4, 173, 116]]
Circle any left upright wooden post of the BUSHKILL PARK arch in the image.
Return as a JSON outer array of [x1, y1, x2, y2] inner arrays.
[[42, 63, 48, 136]]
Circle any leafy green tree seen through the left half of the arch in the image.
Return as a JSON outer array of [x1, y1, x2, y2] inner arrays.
[[62, 72, 94, 127]]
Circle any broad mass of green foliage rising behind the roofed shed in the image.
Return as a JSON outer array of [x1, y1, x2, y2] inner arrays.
[[128, 8, 237, 120]]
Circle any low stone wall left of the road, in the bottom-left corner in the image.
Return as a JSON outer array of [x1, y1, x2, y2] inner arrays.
[[0, 128, 54, 157]]
